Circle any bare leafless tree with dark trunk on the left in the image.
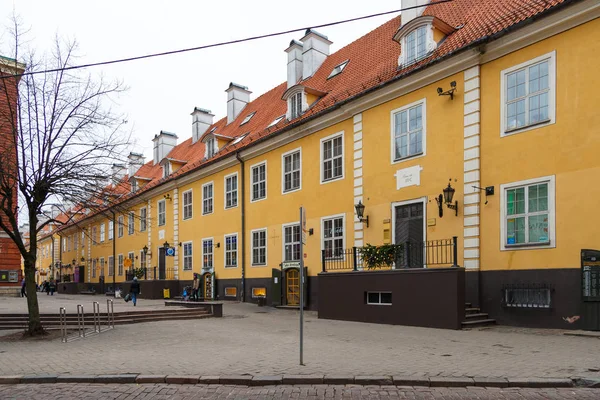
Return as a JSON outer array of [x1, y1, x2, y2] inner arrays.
[[0, 19, 129, 335]]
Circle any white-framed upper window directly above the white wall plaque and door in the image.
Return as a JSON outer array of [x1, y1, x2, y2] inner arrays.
[[392, 100, 425, 161]]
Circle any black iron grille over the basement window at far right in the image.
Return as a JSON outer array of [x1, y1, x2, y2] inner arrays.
[[502, 283, 554, 308]]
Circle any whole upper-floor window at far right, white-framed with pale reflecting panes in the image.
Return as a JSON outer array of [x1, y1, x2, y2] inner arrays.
[[501, 52, 556, 135]]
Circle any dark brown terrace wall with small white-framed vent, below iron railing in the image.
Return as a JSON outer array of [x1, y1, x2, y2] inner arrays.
[[318, 268, 465, 329]]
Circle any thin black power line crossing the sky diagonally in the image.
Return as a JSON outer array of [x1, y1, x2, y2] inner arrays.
[[0, 0, 454, 79]]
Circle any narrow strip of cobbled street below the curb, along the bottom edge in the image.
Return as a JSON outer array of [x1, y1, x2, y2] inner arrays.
[[0, 383, 600, 400]]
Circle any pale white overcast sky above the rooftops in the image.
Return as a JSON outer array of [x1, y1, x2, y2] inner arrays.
[[0, 0, 401, 161]]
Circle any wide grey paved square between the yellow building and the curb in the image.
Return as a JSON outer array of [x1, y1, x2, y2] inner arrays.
[[0, 296, 600, 382]]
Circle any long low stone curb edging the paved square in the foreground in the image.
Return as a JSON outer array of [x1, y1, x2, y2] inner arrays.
[[0, 374, 580, 389]]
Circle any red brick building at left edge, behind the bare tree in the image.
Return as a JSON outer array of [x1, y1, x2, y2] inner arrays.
[[0, 56, 25, 287]]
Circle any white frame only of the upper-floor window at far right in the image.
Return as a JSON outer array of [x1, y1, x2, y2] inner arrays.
[[500, 51, 556, 137]]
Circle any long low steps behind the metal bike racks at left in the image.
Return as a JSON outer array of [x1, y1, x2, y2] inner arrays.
[[0, 308, 213, 330]]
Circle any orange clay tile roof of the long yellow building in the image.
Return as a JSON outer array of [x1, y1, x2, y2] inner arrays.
[[56, 0, 576, 231]]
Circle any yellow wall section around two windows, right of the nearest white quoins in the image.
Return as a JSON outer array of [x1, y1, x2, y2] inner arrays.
[[481, 20, 600, 270]]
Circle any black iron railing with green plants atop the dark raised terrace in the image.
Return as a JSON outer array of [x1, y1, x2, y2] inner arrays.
[[321, 236, 458, 272]]
